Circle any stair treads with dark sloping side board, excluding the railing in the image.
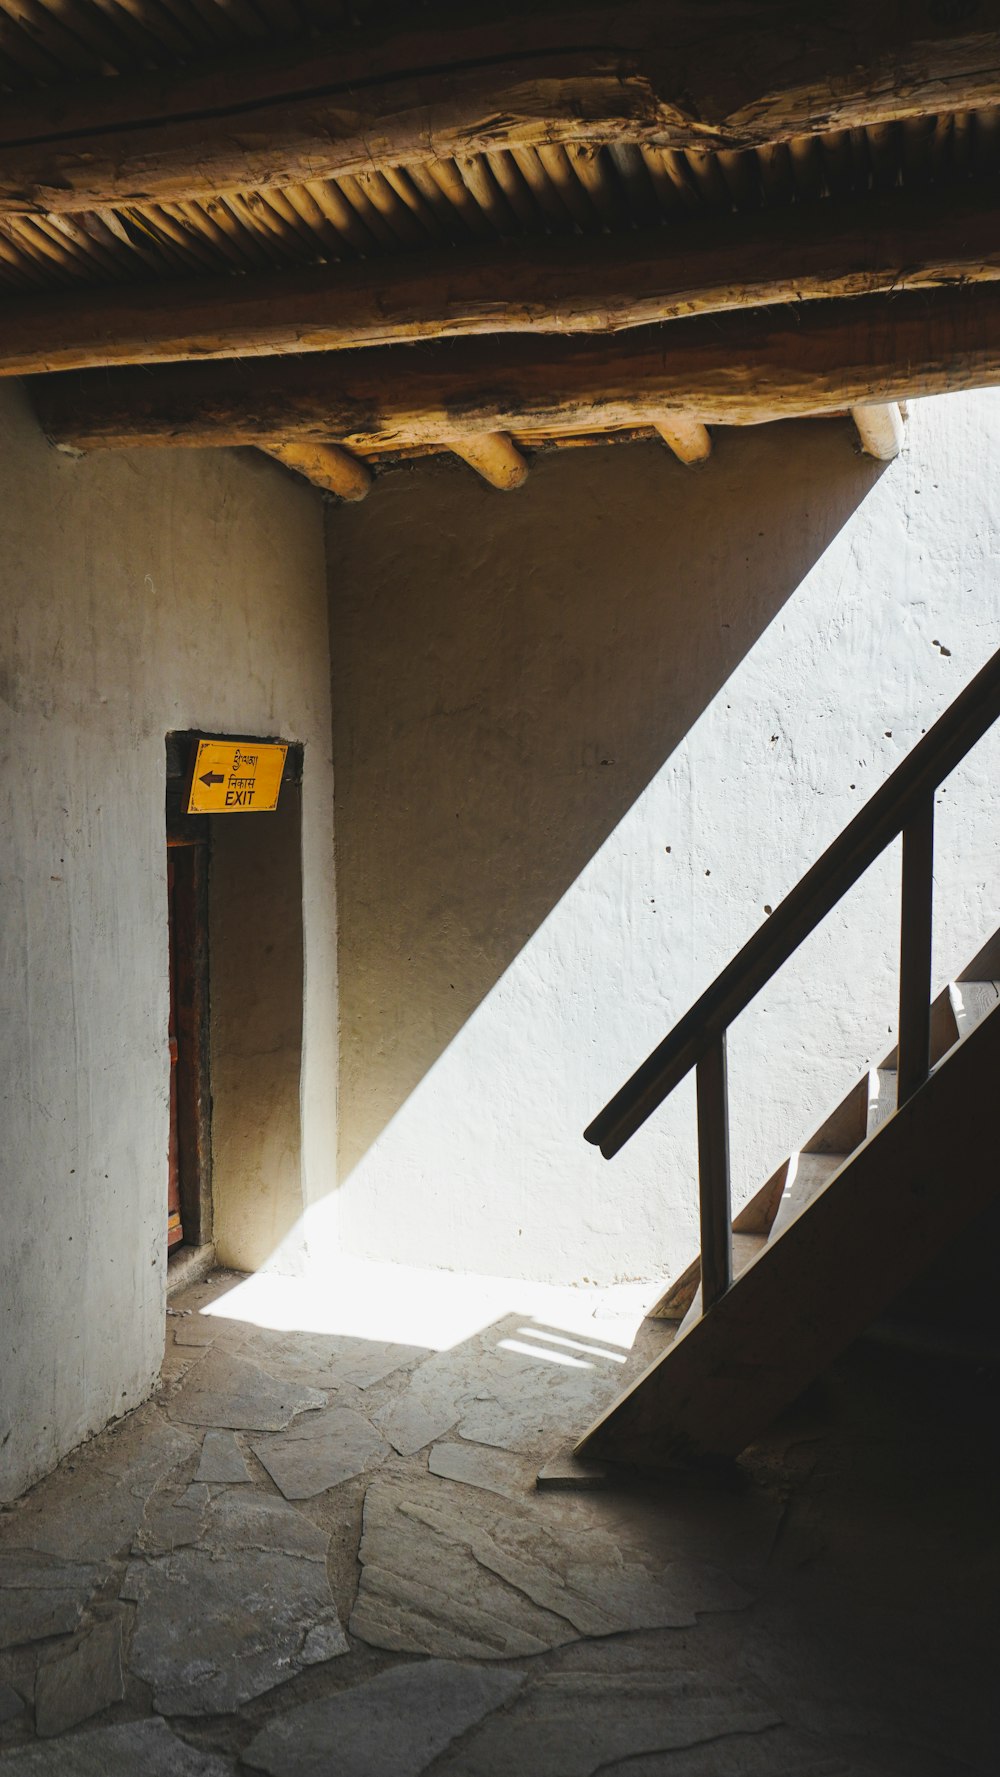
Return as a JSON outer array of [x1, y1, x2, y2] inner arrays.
[[577, 981, 1000, 1468]]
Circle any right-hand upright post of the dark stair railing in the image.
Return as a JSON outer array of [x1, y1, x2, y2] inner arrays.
[[897, 791, 934, 1105]]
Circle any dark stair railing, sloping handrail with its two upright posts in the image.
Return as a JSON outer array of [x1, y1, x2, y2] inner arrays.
[[584, 650, 1000, 1304]]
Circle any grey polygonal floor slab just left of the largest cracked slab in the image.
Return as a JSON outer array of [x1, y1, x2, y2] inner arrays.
[[123, 1491, 346, 1715]]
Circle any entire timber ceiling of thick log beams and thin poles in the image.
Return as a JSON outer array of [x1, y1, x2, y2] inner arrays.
[[0, 0, 1000, 498]]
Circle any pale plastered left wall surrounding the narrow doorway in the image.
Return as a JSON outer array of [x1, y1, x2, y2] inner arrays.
[[0, 386, 336, 1498]]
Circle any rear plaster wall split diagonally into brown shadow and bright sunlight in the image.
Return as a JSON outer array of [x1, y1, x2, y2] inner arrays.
[[329, 394, 1000, 1279]]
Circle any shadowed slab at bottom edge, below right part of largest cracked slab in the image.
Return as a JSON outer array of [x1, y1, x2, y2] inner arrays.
[[426, 1672, 782, 1777]]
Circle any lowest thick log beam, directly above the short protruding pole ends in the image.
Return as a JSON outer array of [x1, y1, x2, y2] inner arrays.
[[27, 284, 1000, 451]]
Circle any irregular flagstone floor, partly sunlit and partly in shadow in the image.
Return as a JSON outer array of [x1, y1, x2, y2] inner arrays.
[[0, 1267, 1000, 1777]]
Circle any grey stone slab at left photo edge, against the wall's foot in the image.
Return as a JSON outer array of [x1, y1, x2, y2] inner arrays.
[[0, 1407, 197, 1562]]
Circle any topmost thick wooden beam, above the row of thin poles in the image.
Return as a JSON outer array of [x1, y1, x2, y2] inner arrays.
[[0, 0, 1000, 213]]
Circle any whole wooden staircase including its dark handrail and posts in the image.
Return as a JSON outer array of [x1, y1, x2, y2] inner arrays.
[[575, 654, 1000, 1468]]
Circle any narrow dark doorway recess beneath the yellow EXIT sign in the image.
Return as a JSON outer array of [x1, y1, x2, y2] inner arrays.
[[167, 732, 304, 1271]]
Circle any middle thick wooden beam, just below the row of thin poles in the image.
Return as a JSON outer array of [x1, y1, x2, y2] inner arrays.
[[0, 183, 1000, 377]]
